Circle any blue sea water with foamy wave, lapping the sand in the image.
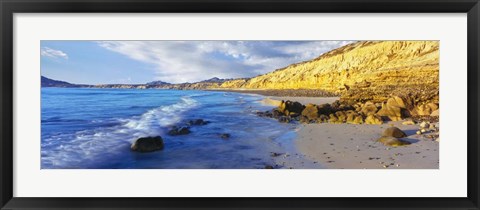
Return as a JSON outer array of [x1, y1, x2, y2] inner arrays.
[[41, 88, 295, 169]]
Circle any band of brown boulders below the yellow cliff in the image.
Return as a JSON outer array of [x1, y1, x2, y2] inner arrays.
[[256, 96, 439, 145]]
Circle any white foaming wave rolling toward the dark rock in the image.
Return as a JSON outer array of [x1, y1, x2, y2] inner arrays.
[[42, 97, 198, 168]]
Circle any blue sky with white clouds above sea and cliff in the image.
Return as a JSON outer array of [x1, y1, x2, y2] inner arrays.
[[40, 41, 352, 84]]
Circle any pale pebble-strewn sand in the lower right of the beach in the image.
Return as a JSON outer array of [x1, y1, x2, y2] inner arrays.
[[295, 121, 439, 169]]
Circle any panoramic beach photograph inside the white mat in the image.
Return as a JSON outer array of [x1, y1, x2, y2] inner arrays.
[[40, 40, 438, 170]]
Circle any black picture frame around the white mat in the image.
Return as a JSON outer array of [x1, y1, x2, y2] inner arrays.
[[0, 0, 480, 209]]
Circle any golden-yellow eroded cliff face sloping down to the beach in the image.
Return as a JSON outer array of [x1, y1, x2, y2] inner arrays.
[[220, 41, 439, 100]]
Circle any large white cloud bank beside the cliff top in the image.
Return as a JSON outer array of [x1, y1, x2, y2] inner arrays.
[[98, 41, 351, 83]]
